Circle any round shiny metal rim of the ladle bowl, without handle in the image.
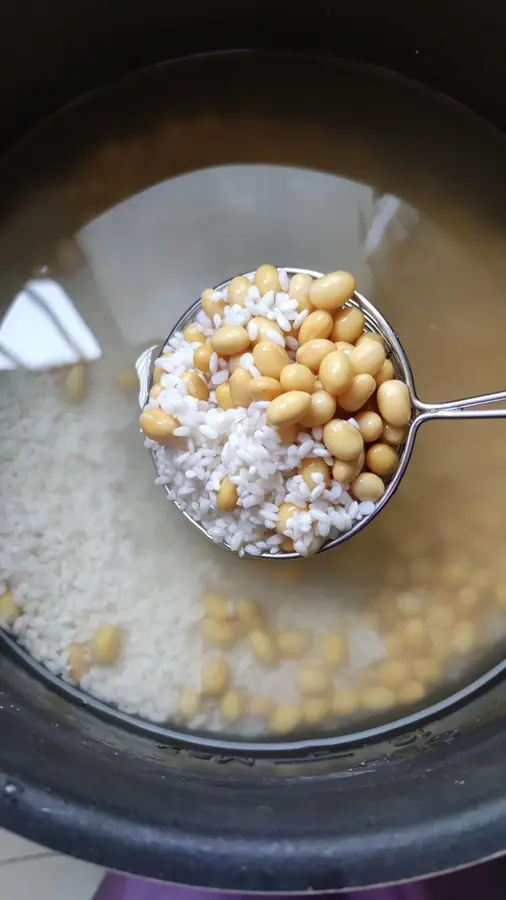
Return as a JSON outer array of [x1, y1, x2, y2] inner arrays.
[[145, 266, 419, 562]]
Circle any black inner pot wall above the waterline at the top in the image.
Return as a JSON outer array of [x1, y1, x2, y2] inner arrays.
[[0, 0, 506, 144]]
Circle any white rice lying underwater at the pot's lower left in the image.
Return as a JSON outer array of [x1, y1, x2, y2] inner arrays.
[[0, 363, 384, 735]]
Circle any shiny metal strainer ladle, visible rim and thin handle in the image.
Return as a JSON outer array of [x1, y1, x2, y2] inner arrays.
[[136, 268, 506, 560]]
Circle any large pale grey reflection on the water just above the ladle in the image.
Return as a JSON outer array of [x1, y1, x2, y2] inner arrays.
[[77, 165, 373, 344]]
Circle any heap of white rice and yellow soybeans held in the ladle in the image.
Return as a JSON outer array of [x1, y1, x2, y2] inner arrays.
[[140, 265, 411, 556]]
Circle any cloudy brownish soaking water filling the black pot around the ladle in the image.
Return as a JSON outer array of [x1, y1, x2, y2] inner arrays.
[[0, 52, 506, 734]]
